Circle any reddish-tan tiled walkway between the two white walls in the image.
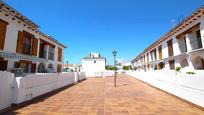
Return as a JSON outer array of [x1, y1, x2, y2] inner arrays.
[[4, 75, 204, 115]]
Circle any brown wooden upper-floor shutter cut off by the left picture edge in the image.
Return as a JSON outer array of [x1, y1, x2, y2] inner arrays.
[[0, 19, 8, 50]]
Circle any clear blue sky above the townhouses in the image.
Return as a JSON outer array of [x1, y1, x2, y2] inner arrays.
[[4, 0, 204, 64]]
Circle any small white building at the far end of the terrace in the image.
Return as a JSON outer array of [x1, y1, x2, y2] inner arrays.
[[82, 53, 106, 76]]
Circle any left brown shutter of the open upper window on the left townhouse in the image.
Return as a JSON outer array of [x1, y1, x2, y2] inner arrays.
[[16, 31, 23, 53]]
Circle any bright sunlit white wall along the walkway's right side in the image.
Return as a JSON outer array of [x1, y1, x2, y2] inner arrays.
[[126, 70, 204, 107]]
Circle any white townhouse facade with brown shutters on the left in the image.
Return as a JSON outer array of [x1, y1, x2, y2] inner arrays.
[[0, 1, 66, 73]]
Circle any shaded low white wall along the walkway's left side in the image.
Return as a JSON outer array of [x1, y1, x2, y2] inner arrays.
[[0, 72, 86, 110]]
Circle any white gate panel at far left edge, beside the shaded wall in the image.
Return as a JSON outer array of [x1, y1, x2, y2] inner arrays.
[[0, 71, 14, 110]]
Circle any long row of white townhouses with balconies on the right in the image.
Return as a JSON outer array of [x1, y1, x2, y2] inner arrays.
[[132, 7, 204, 71]]
